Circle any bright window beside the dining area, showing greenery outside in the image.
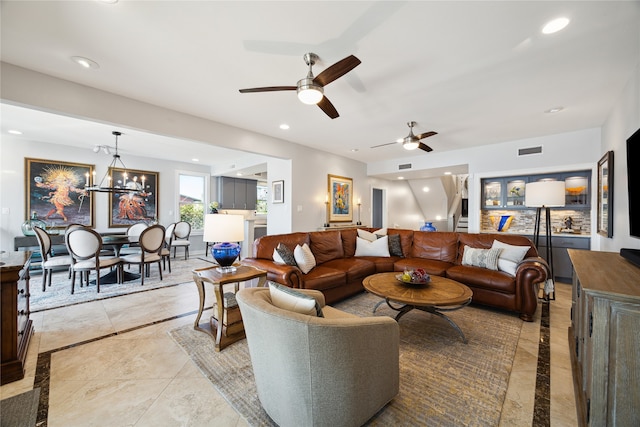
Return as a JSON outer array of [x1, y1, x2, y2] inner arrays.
[[178, 172, 209, 230]]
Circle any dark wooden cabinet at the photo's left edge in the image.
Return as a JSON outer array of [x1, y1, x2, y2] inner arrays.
[[0, 251, 33, 384]]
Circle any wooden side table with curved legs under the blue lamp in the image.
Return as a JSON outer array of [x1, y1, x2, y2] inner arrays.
[[193, 265, 267, 351]]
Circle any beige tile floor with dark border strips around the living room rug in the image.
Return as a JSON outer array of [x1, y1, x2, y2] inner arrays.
[[0, 274, 577, 427]]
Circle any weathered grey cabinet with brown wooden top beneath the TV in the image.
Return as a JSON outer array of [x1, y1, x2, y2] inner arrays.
[[568, 249, 640, 427]]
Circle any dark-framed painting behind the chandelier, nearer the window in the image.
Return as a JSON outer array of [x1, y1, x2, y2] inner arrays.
[[109, 168, 158, 227]]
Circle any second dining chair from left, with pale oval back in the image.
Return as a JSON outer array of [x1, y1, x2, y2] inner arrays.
[[67, 227, 122, 294]]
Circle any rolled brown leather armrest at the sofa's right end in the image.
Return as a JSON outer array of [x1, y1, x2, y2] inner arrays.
[[516, 257, 549, 322]]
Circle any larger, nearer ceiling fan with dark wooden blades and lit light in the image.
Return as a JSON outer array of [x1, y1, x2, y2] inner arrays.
[[240, 53, 360, 119]]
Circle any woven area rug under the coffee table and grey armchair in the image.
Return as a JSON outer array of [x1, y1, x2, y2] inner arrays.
[[169, 293, 522, 426]]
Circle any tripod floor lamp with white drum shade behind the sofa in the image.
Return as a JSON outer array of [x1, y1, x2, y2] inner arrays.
[[524, 181, 565, 299]]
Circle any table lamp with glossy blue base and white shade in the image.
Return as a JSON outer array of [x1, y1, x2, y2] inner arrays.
[[202, 214, 244, 273]]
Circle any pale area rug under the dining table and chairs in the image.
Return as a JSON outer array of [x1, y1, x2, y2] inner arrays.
[[29, 256, 212, 313]]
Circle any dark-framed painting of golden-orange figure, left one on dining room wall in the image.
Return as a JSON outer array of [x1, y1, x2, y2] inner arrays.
[[25, 158, 94, 229]]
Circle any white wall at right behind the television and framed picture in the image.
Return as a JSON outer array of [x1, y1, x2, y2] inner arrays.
[[596, 63, 640, 252]]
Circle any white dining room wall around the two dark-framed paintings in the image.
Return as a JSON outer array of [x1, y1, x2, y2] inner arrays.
[[0, 134, 208, 250]]
